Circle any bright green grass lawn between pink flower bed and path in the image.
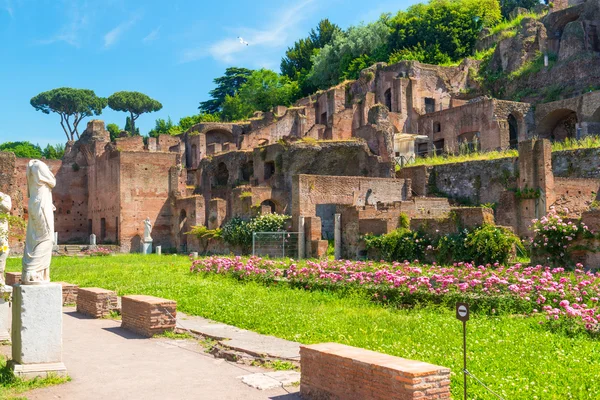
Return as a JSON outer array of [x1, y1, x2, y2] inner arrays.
[[5, 255, 600, 399]]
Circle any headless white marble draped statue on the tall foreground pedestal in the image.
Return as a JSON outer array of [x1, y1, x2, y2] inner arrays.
[[21, 160, 56, 285]]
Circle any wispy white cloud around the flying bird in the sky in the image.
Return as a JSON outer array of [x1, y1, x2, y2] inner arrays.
[[181, 0, 315, 64]]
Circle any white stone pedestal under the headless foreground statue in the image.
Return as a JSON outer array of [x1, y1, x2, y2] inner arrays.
[[10, 283, 67, 379]]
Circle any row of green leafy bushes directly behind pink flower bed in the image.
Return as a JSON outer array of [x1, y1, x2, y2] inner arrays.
[[364, 224, 525, 264]]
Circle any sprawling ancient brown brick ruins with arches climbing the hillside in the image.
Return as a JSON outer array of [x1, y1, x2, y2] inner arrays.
[[0, 1, 600, 257]]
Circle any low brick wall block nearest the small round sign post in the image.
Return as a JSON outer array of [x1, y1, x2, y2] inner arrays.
[[300, 343, 450, 400]]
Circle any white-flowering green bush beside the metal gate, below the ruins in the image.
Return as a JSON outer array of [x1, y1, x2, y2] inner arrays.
[[221, 213, 290, 250]]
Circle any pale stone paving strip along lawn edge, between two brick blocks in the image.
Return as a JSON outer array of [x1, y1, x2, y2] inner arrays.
[[177, 311, 300, 361]]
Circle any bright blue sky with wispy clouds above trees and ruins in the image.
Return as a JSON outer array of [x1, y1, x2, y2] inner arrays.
[[0, 0, 416, 147]]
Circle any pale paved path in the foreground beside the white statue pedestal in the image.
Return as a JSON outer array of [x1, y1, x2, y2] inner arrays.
[[9, 308, 300, 400]]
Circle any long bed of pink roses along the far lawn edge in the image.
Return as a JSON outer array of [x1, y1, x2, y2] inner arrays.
[[191, 256, 600, 335]]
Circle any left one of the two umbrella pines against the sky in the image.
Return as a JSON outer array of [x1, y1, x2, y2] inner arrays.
[[30, 87, 107, 141]]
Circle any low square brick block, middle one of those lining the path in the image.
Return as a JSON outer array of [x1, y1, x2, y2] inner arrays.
[[121, 295, 177, 337]]
